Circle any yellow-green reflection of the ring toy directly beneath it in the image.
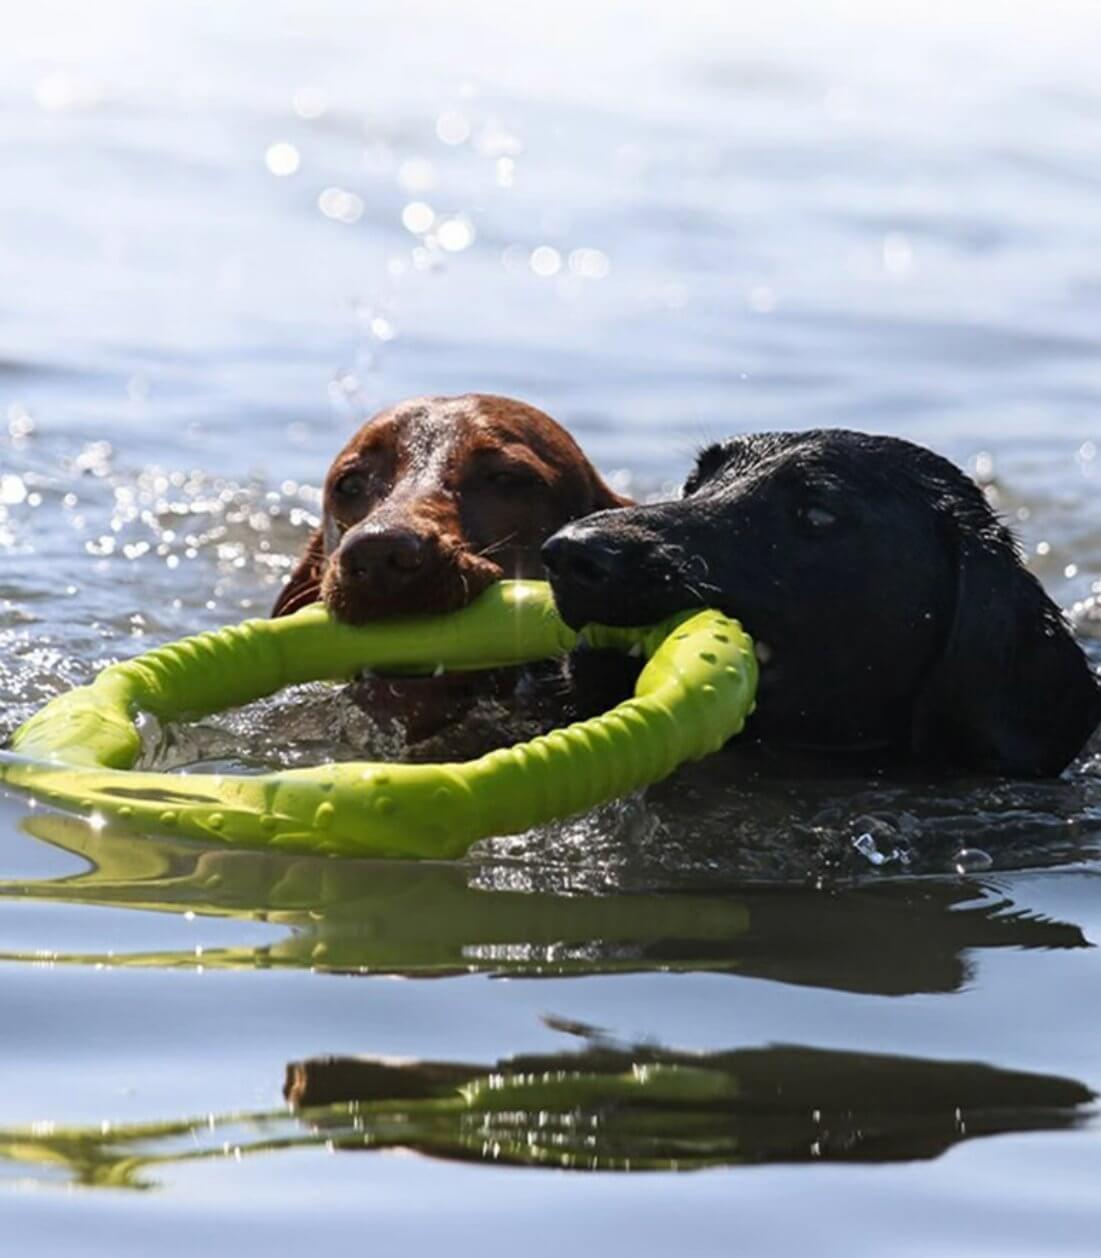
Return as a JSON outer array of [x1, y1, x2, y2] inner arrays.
[[0, 810, 749, 975]]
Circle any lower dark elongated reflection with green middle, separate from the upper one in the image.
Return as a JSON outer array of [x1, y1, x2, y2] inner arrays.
[[284, 1028, 1095, 1171]]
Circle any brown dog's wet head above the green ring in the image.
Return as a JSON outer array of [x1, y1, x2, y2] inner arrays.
[[272, 394, 628, 623]]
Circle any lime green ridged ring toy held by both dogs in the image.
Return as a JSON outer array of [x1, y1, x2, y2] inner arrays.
[[0, 581, 756, 858]]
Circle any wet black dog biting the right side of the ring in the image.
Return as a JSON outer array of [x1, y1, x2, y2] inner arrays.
[[544, 430, 1101, 776]]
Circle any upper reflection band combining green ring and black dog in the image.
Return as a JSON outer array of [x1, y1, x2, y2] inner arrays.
[[0, 810, 1090, 995]]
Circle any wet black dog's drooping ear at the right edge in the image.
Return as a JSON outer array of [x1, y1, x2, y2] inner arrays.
[[914, 518, 1101, 776]]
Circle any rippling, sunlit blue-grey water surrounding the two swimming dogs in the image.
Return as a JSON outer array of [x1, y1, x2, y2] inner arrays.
[[0, 0, 1101, 1254]]
